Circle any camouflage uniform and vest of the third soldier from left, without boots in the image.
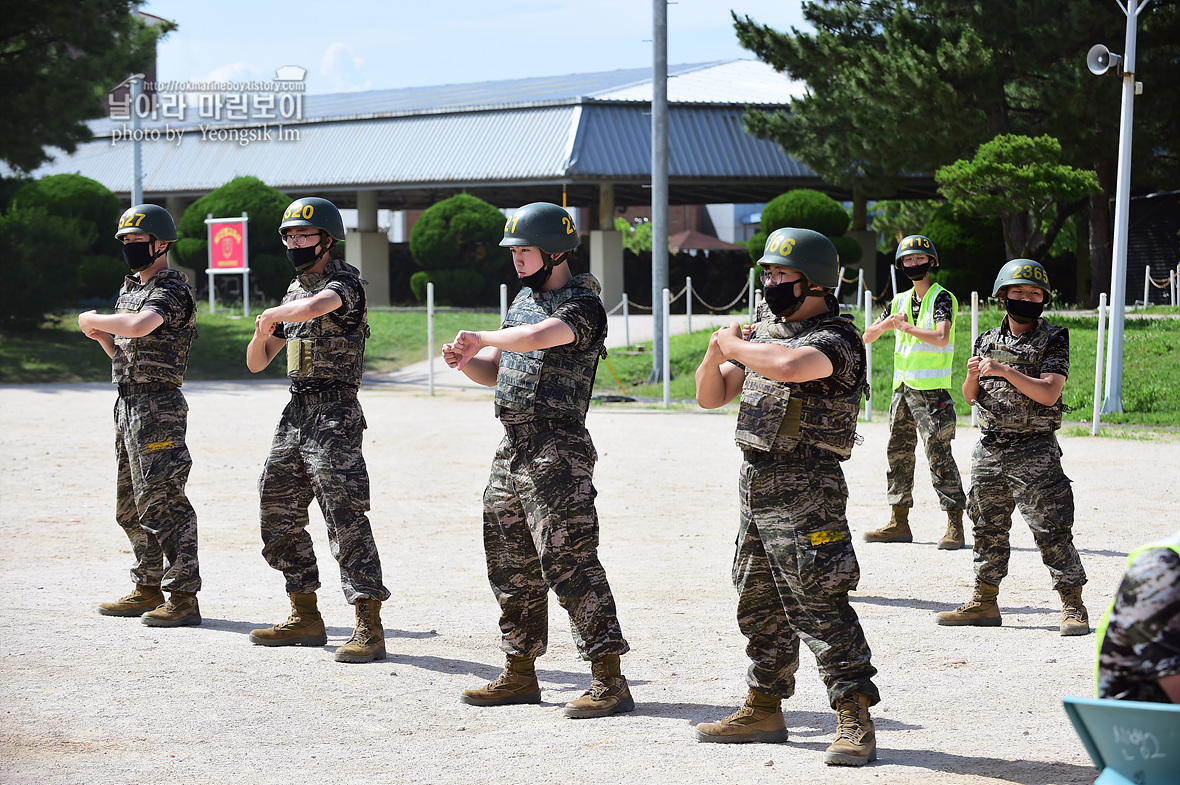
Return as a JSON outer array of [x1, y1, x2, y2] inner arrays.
[[484, 275, 629, 660]]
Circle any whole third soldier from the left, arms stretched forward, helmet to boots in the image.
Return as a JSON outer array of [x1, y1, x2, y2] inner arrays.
[[443, 202, 635, 718]]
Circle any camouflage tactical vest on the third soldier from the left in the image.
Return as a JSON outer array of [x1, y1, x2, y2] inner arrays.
[[496, 274, 607, 423]]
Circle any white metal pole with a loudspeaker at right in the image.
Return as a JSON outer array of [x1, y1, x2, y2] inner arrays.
[[1086, 0, 1152, 414]]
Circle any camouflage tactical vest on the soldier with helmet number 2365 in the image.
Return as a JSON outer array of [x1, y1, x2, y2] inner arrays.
[[976, 319, 1064, 433]]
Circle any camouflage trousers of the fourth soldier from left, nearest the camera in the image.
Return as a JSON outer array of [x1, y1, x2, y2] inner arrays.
[[733, 450, 879, 706]]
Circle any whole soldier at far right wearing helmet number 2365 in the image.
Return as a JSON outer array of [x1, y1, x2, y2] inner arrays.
[[937, 259, 1090, 635]]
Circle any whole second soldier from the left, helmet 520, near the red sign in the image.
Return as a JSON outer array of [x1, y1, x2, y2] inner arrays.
[[245, 197, 389, 662]]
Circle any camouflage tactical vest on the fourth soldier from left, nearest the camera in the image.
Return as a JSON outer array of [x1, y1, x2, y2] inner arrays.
[[735, 314, 865, 460]]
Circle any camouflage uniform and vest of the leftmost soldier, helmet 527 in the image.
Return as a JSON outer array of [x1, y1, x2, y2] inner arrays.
[[111, 268, 201, 594]]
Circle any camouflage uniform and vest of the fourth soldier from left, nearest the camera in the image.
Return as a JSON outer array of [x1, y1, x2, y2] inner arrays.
[[733, 297, 880, 707]]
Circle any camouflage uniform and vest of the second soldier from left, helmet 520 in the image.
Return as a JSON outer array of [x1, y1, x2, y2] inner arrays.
[[258, 260, 389, 603]]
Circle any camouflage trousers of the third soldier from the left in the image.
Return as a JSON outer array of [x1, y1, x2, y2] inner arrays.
[[484, 429, 629, 660]]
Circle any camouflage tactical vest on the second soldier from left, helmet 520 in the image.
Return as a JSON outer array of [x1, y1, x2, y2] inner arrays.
[[283, 259, 369, 387]]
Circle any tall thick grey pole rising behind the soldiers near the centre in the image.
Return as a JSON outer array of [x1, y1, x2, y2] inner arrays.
[[650, 0, 668, 384]]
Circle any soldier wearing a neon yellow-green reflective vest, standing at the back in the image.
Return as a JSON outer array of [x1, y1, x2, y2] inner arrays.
[[865, 235, 966, 550]]
